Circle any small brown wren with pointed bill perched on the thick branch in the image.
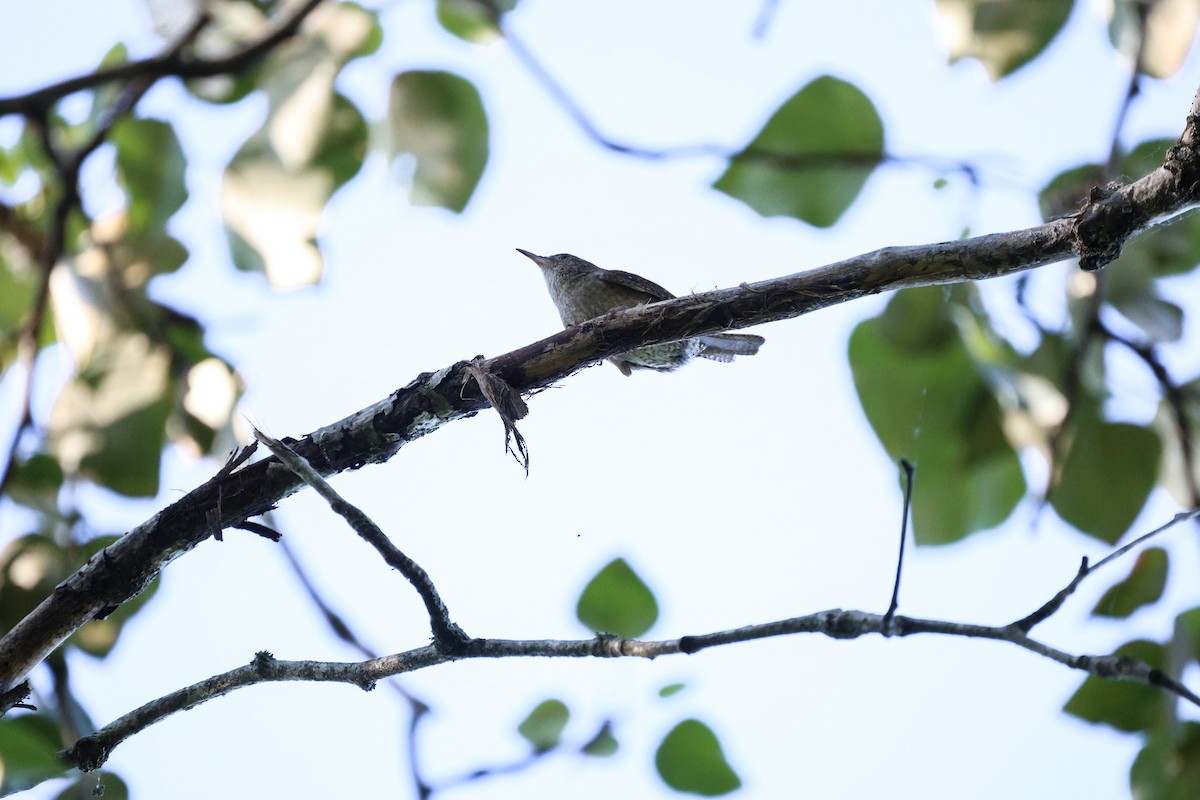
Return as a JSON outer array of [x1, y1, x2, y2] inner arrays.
[[517, 247, 766, 375]]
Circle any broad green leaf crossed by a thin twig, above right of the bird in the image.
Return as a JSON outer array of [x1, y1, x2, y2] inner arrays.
[[713, 76, 883, 228]]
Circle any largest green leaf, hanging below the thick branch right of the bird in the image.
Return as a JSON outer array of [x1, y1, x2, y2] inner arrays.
[[850, 287, 1026, 545]]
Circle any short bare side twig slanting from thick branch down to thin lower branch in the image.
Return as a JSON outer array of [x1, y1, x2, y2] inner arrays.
[[254, 428, 470, 654]]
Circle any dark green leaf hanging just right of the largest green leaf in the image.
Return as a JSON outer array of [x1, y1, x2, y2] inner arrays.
[[1049, 403, 1162, 545]]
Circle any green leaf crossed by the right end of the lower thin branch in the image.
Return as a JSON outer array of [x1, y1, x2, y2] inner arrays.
[[1063, 640, 1170, 733]]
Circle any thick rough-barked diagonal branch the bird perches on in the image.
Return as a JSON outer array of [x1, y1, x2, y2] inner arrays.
[[0, 104, 1200, 691]]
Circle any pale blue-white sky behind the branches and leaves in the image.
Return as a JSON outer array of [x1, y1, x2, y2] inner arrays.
[[0, 0, 1200, 800]]
